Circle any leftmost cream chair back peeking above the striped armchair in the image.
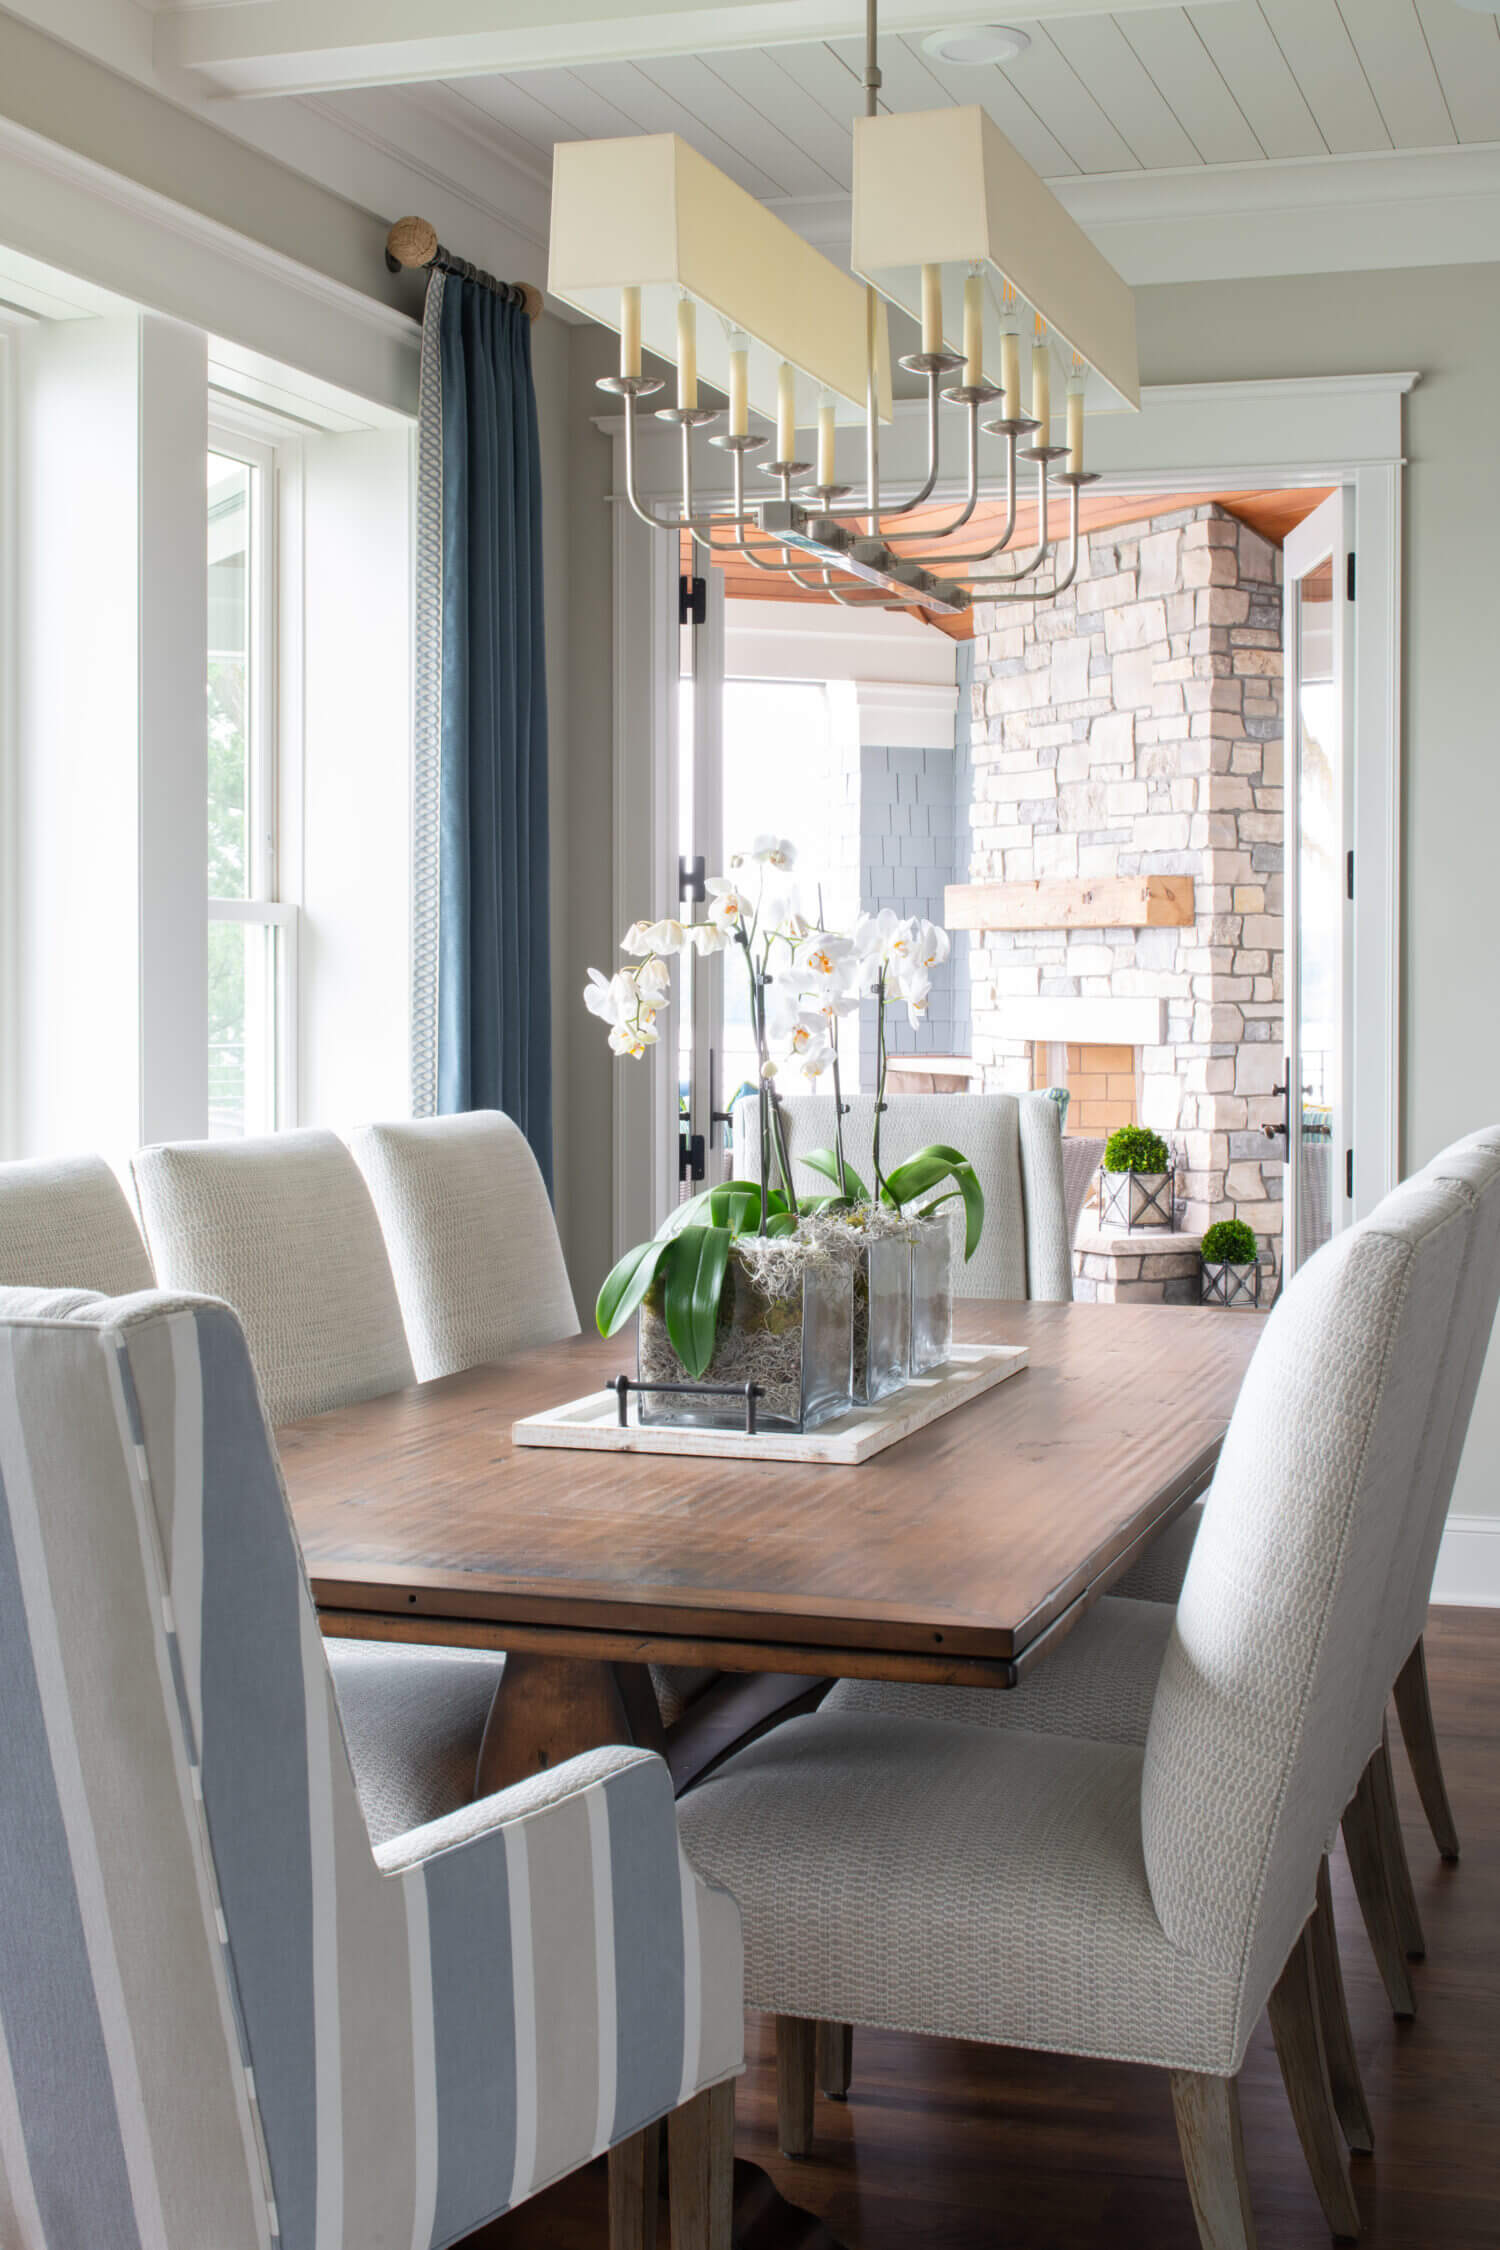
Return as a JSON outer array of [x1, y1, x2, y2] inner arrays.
[[0, 1157, 155, 1296]]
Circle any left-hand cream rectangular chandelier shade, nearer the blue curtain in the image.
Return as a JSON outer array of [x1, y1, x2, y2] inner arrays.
[[546, 133, 891, 428]]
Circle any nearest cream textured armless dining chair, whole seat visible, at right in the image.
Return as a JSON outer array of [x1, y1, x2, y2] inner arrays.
[[679, 1181, 1473, 2250]]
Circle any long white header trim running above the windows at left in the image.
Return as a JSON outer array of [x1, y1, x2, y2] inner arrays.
[[0, 117, 421, 414]]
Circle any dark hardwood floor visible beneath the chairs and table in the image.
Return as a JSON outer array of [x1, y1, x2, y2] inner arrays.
[[466, 1609, 1500, 2250]]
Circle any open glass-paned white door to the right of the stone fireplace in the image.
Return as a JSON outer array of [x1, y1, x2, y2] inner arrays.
[[1268, 486, 1354, 1274]]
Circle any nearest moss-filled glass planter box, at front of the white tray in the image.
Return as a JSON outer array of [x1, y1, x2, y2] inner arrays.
[[636, 1238, 852, 1431]]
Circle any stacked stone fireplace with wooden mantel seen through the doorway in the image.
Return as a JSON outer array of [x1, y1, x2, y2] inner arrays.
[[969, 506, 1282, 1247]]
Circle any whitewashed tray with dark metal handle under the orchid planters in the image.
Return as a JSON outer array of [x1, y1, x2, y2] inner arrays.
[[510, 1343, 1030, 1467]]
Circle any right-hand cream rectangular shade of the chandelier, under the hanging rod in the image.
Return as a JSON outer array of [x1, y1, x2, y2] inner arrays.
[[850, 106, 1140, 423]]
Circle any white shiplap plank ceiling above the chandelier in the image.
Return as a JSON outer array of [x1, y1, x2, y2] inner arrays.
[[425, 0, 1500, 212]]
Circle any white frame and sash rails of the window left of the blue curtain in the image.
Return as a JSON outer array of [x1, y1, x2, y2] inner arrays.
[[209, 394, 301, 1132]]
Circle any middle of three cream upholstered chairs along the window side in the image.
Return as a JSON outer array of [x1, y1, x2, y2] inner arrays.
[[133, 1132, 504, 1841]]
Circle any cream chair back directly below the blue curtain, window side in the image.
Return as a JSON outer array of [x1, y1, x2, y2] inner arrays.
[[349, 1109, 578, 1384]]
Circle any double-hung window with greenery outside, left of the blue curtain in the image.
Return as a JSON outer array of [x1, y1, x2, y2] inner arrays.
[[207, 428, 297, 1139]]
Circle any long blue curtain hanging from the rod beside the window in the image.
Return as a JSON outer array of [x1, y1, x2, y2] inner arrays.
[[414, 272, 551, 1186]]
